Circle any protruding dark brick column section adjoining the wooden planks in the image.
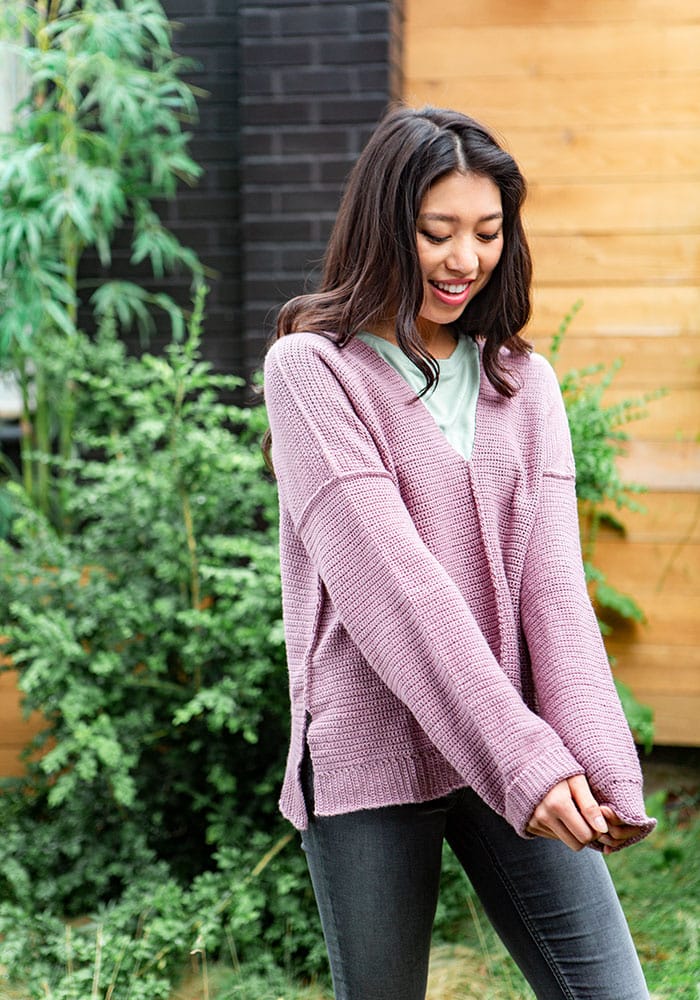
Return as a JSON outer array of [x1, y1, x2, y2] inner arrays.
[[240, 0, 401, 376]]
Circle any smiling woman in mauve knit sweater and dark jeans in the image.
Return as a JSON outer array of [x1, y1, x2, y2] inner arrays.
[[265, 108, 654, 1000]]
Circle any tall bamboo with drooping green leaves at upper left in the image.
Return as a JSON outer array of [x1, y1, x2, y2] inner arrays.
[[0, 0, 202, 524]]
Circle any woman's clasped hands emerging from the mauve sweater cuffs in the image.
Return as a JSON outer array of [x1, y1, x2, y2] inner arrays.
[[527, 774, 639, 854]]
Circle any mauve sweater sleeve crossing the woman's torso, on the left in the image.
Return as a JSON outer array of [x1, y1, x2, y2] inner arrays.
[[265, 335, 583, 835]]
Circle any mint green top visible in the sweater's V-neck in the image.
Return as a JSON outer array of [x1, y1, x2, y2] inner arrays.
[[357, 330, 479, 459]]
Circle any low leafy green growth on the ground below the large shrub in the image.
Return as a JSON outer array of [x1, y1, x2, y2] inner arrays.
[[0, 834, 326, 1000]]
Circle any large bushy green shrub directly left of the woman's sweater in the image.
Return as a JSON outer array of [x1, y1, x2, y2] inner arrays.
[[0, 296, 287, 878]]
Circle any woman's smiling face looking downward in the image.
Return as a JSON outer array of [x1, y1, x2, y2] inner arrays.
[[416, 172, 503, 332]]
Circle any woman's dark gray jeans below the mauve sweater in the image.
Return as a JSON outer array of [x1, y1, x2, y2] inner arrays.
[[302, 774, 649, 1000]]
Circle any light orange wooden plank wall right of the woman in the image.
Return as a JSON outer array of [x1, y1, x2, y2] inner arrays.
[[404, 0, 700, 745]]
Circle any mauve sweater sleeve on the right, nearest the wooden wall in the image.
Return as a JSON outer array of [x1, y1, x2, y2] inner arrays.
[[521, 364, 655, 846]]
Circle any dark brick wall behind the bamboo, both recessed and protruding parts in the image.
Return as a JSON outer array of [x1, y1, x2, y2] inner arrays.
[[88, 0, 401, 376]]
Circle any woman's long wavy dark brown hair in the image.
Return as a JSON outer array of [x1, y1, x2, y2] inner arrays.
[[266, 106, 532, 462]]
